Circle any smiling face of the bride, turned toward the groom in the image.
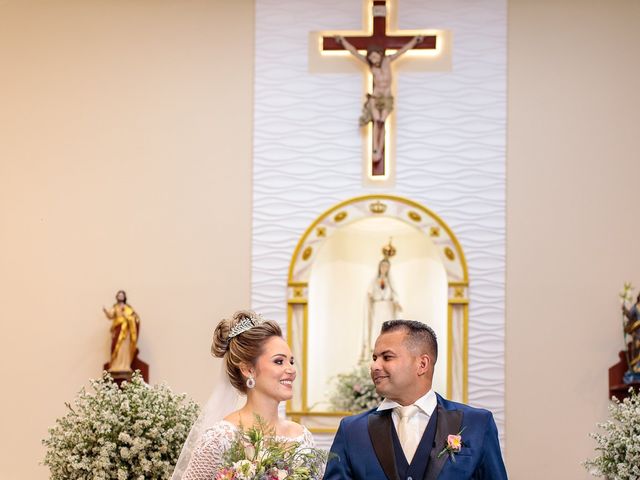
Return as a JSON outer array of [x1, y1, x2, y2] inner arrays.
[[255, 337, 296, 402]]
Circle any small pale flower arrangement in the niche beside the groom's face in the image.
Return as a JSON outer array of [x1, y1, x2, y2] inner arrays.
[[329, 361, 382, 413]]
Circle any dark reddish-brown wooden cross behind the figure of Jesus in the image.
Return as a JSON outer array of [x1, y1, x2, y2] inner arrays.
[[322, 0, 436, 178]]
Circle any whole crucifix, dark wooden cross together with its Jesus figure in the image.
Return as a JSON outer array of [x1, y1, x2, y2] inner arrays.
[[322, 0, 437, 179]]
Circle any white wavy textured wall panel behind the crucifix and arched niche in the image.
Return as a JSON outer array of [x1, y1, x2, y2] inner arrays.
[[252, 0, 506, 450]]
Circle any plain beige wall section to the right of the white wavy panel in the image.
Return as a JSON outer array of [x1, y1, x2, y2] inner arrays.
[[506, 0, 640, 480]]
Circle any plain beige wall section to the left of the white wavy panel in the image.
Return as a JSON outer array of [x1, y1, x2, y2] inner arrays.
[[0, 0, 253, 480]]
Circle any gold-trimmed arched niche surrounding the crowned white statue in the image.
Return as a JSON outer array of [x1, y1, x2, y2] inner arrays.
[[287, 195, 469, 433]]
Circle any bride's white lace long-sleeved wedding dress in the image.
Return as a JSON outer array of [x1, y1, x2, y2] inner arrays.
[[182, 420, 315, 480]]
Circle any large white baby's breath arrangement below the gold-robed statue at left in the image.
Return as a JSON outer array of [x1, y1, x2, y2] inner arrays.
[[43, 372, 198, 480]]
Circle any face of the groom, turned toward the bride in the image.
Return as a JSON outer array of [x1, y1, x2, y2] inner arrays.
[[371, 330, 420, 405]]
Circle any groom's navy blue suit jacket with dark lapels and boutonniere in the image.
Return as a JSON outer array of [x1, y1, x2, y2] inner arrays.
[[324, 394, 507, 480]]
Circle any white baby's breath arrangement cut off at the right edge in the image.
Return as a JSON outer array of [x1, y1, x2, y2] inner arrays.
[[584, 389, 640, 480]]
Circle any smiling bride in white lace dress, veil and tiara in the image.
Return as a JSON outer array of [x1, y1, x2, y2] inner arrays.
[[171, 311, 314, 480]]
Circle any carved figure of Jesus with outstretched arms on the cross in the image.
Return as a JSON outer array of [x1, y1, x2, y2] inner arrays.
[[335, 35, 424, 162]]
